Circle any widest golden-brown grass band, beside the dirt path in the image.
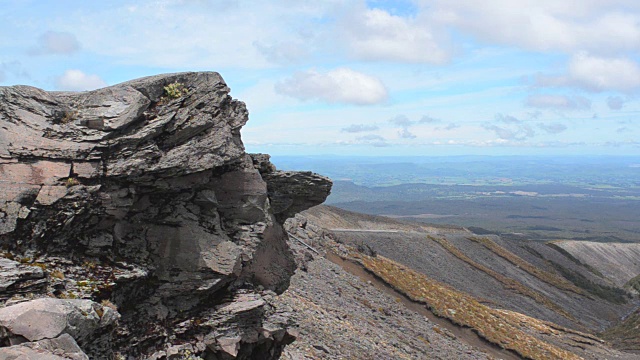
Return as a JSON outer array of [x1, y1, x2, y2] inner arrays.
[[352, 254, 581, 360]]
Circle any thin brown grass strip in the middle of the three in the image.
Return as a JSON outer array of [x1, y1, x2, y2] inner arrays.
[[428, 236, 577, 321]]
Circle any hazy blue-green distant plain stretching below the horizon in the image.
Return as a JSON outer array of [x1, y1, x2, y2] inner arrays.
[[273, 156, 640, 242]]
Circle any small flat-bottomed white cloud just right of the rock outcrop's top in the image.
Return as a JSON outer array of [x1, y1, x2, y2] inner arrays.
[[275, 68, 387, 105]]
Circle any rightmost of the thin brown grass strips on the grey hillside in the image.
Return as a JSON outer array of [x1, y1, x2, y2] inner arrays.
[[467, 237, 588, 296]]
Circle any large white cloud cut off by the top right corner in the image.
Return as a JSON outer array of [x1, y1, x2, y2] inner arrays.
[[421, 0, 640, 54]]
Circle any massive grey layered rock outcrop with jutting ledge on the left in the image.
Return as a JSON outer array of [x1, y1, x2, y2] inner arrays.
[[0, 72, 331, 359]]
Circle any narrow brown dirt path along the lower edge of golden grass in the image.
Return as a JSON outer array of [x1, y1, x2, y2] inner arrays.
[[326, 252, 521, 360]]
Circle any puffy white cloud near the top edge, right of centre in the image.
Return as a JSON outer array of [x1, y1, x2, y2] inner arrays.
[[338, 8, 450, 64]]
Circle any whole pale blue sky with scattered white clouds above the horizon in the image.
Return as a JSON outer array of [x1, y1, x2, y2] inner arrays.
[[0, 0, 640, 156]]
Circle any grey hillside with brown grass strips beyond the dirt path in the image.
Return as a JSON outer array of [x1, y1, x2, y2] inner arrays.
[[285, 206, 636, 359]]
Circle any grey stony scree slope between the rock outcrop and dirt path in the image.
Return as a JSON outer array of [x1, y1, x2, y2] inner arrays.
[[278, 257, 487, 359]]
